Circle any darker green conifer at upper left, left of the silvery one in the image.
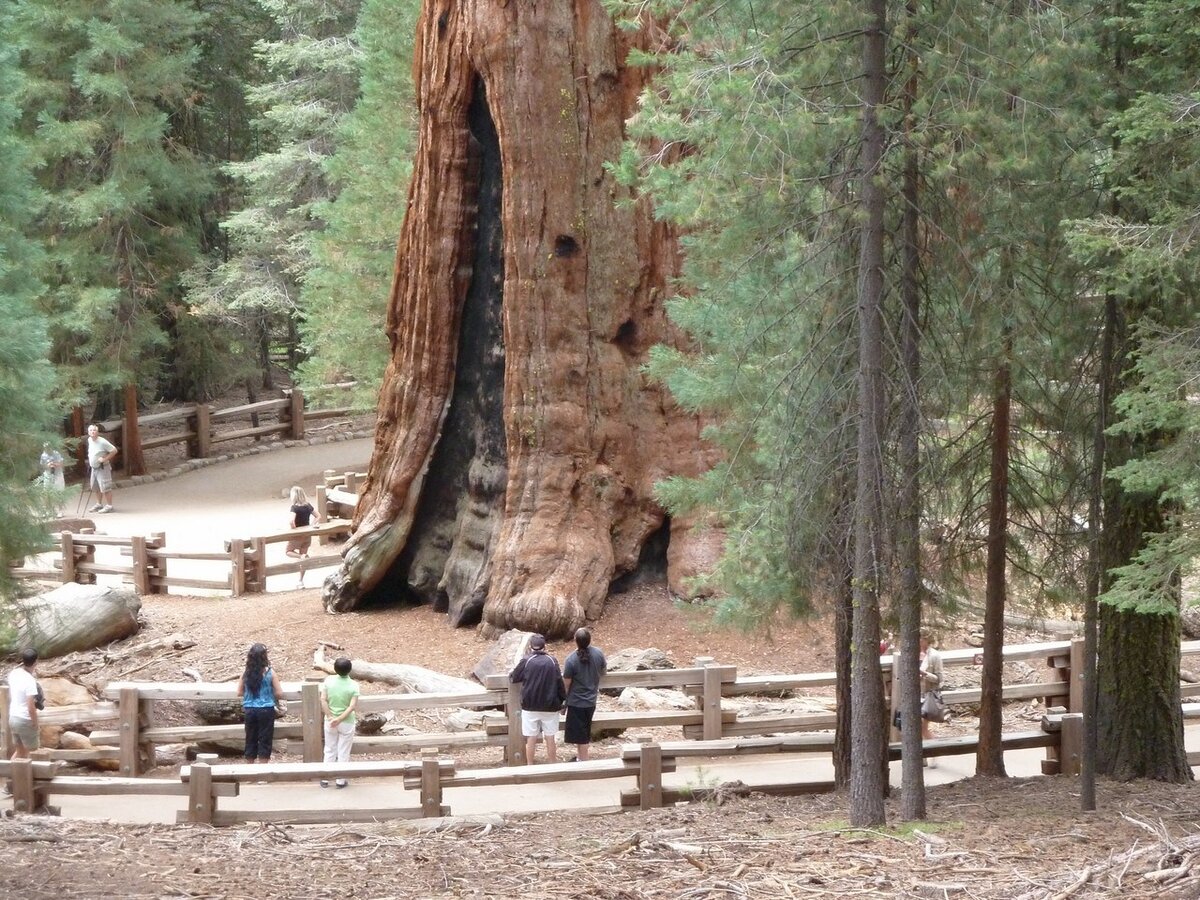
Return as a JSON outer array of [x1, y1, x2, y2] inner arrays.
[[13, 0, 210, 397]]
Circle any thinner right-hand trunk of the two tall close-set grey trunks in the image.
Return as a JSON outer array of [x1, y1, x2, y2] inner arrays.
[[892, 12, 925, 821]]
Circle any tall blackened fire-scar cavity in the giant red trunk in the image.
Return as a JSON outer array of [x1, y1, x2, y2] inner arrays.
[[364, 77, 508, 625]]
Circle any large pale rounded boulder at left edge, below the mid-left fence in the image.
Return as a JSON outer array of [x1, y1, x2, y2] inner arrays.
[[0, 583, 142, 658]]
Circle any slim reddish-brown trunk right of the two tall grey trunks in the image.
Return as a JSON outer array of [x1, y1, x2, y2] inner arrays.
[[976, 316, 1013, 778]]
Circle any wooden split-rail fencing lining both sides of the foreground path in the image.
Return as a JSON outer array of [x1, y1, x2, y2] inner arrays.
[[0, 640, 1200, 824]]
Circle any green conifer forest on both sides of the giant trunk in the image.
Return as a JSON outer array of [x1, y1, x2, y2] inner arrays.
[[0, 0, 1200, 822]]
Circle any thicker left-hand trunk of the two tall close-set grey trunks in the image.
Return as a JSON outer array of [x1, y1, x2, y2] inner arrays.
[[850, 0, 887, 827]]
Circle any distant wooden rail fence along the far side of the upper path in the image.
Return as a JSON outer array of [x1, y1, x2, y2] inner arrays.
[[66, 385, 354, 475]]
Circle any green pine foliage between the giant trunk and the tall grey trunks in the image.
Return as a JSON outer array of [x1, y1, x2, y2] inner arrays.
[[616, 2, 859, 624]]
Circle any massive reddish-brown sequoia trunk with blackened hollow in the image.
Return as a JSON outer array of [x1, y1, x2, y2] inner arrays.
[[325, 0, 715, 635]]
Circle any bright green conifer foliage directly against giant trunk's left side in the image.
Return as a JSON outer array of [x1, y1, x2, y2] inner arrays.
[[300, 0, 420, 407]]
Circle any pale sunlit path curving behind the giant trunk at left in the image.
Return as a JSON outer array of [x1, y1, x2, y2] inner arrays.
[[56, 438, 372, 593]]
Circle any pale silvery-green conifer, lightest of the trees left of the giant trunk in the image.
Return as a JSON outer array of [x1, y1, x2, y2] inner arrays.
[[188, 0, 360, 377]]
